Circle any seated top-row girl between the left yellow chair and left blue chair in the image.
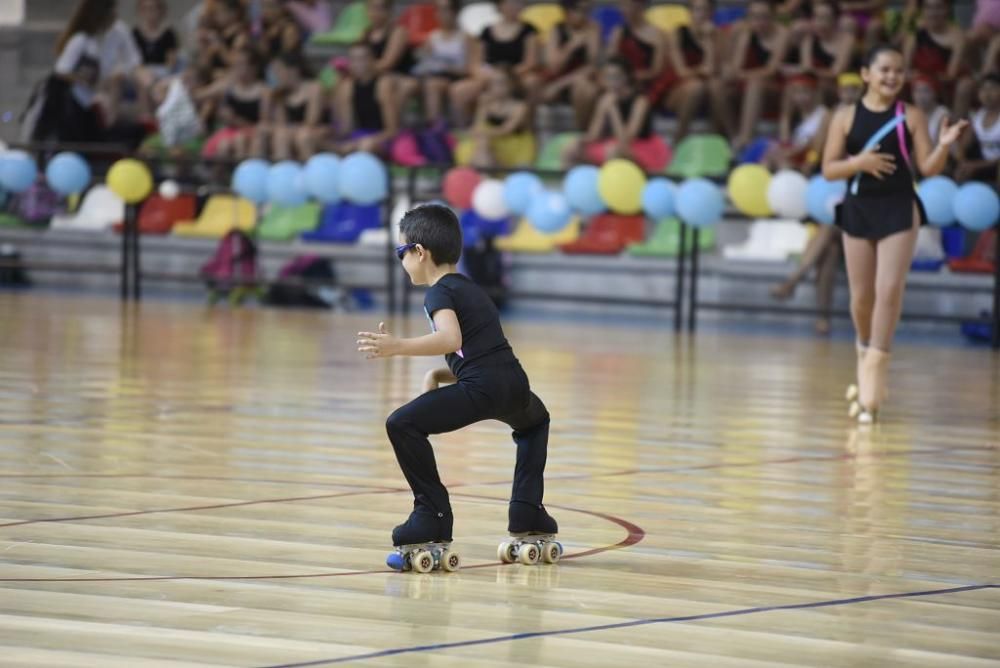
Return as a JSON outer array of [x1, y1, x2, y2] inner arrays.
[[542, 0, 601, 128]]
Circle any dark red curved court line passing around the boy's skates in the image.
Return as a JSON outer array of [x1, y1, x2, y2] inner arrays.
[[0, 489, 646, 582]]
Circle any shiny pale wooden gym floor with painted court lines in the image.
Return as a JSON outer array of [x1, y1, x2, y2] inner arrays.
[[0, 294, 1000, 668]]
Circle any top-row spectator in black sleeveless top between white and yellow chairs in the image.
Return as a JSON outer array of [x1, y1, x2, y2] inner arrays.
[[450, 0, 541, 124]]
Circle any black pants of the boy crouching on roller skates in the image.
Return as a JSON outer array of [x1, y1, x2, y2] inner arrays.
[[385, 362, 549, 513]]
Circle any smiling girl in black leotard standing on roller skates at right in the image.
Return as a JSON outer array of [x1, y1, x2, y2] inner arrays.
[[823, 46, 968, 422]]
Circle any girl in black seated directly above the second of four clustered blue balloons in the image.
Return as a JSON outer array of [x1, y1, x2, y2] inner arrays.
[[270, 53, 329, 162]]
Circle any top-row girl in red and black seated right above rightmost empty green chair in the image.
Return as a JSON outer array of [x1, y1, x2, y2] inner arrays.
[[664, 0, 726, 145]]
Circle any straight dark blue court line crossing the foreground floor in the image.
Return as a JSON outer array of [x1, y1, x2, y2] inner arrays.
[[262, 584, 1000, 668]]
